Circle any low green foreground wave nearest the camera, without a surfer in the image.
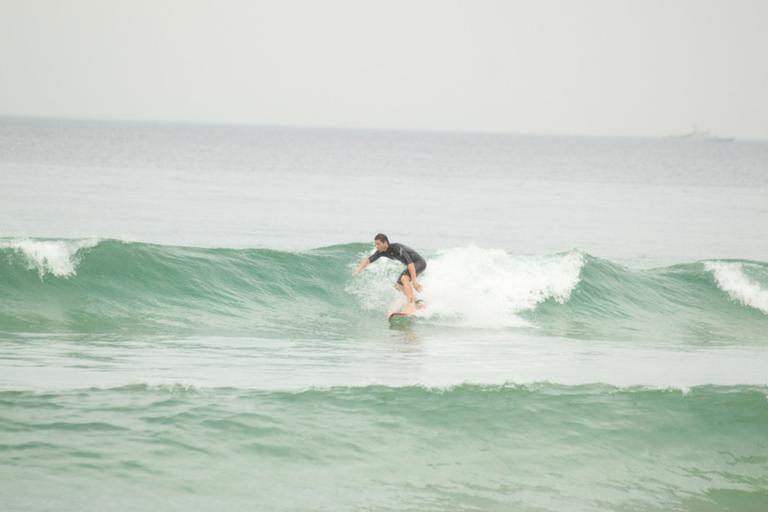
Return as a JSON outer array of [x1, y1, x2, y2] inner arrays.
[[0, 384, 768, 511]]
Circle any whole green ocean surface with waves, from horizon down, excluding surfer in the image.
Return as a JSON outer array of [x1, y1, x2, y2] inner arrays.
[[0, 118, 768, 512]]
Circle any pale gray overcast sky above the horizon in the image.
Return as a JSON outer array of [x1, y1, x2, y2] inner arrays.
[[0, 0, 768, 138]]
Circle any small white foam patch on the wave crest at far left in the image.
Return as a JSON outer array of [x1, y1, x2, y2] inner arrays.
[[0, 239, 98, 278]]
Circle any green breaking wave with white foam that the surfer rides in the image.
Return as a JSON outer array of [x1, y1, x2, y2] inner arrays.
[[0, 239, 768, 343]]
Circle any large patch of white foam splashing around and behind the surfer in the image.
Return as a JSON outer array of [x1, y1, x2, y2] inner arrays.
[[348, 246, 584, 328]]
